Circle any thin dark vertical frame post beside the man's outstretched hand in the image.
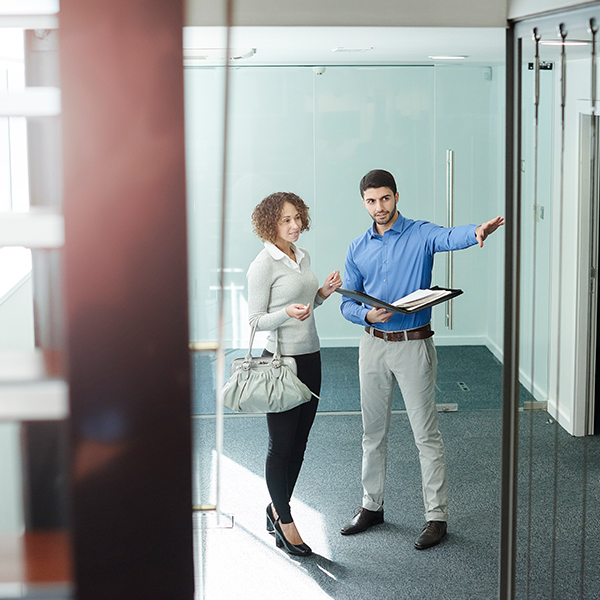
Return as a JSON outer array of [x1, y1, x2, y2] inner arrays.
[[499, 25, 521, 600]]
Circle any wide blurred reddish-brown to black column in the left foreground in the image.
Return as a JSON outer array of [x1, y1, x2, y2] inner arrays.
[[60, 0, 193, 600]]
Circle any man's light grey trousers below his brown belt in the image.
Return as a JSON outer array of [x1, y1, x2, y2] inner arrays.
[[359, 332, 448, 521]]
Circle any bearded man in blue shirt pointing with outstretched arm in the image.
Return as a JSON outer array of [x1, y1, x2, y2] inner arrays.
[[341, 170, 504, 550]]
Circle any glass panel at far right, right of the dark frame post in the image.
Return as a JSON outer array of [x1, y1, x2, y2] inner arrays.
[[501, 4, 600, 599]]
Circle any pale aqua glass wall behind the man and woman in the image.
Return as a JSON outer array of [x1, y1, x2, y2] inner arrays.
[[186, 65, 504, 350]]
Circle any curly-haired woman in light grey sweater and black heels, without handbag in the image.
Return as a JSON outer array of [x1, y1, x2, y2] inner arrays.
[[248, 192, 342, 556]]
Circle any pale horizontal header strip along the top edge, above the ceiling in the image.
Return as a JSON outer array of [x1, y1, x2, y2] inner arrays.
[[186, 0, 507, 27]]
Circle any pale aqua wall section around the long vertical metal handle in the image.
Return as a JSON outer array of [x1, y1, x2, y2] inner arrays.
[[431, 65, 505, 352]]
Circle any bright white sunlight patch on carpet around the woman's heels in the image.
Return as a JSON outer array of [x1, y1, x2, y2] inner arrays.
[[194, 453, 336, 600]]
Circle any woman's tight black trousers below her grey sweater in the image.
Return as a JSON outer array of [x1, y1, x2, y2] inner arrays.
[[263, 350, 321, 523]]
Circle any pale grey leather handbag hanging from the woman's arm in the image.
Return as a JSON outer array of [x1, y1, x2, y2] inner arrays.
[[223, 323, 318, 413]]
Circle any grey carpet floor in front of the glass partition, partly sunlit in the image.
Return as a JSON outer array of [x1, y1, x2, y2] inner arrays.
[[194, 410, 600, 600]]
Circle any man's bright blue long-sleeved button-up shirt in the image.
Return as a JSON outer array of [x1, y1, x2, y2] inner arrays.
[[341, 214, 477, 331]]
